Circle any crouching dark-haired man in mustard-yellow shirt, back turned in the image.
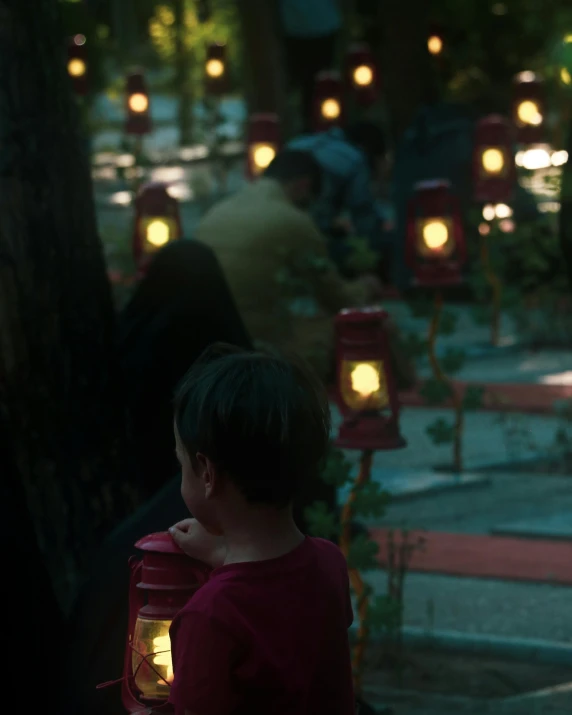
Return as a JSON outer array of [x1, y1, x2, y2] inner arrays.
[[195, 150, 381, 381]]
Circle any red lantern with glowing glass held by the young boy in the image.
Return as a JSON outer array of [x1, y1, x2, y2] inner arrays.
[[122, 532, 210, 713]]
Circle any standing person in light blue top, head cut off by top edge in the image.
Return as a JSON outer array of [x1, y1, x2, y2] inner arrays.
[[279, 0, 343, 131]]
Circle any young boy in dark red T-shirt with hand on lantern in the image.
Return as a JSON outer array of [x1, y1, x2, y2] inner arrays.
[[165, 347, 354, 715]]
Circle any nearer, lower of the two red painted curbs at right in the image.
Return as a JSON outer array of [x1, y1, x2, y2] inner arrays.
[[370, 529, 572, 586]]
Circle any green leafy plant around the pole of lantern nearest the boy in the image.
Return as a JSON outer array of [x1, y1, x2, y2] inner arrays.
[[305, 445, 424, 695]]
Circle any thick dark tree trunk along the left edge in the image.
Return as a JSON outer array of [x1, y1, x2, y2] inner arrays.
[[0, 0, 140, 620]]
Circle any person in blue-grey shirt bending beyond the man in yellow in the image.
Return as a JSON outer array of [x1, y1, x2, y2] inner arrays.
[[288, 122, 393, 282]]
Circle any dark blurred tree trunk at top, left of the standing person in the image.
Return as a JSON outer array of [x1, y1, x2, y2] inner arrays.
[[237, 0, 287, 124]]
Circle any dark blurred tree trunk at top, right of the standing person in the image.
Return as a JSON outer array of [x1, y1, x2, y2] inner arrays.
[[377, 0, 435, 141]]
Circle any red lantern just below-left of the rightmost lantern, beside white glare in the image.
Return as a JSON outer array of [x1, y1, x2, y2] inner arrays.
[[473, 115, 516, 204]]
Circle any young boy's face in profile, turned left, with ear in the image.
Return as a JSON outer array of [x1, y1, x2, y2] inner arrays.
[[175, 426, 222, 536]]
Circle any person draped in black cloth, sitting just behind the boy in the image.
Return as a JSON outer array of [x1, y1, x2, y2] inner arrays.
[[119, 240, 251, 496]]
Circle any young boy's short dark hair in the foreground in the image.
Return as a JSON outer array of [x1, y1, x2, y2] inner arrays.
[[175, 344, 331, 508]]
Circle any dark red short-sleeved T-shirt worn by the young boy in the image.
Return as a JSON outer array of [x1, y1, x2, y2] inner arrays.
[[169, 537, 354, 715]]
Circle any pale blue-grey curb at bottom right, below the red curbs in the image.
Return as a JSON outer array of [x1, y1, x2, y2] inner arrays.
[[350, 625, 572, 667]]
